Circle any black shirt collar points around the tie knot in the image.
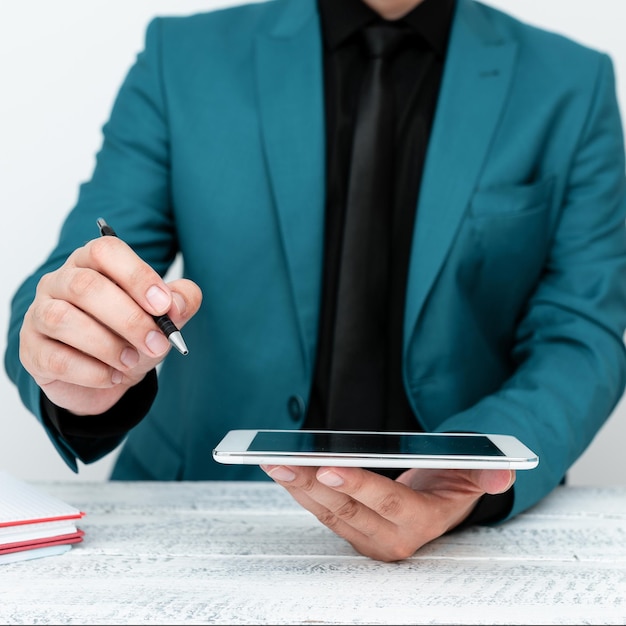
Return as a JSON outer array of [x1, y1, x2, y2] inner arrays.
[[318, 0, 456, 56]]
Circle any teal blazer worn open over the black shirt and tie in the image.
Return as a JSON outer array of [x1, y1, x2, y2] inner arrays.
[[6, 0, 626, 515]]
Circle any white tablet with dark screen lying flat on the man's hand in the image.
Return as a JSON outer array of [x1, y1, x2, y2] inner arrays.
[[213, 430, 539, 470]]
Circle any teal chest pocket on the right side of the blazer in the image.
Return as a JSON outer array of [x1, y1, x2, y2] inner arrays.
[[470, 178, 554, 217]]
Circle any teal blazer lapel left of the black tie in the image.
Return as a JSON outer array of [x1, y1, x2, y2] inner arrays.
[[256, 1, 325, 374]]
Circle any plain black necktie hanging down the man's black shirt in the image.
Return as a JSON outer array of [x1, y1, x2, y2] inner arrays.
[[328, 25, 406, 430]]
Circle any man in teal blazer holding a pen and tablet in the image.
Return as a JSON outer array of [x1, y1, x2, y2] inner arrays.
[[6, 0, 626, 560]]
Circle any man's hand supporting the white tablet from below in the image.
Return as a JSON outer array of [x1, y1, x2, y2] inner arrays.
[[262, 465, 515, 562]]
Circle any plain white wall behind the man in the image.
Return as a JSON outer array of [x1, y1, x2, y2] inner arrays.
[[0, 0, 626, 485]]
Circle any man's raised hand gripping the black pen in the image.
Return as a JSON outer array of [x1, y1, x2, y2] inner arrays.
[[20, 237, 202, 415]]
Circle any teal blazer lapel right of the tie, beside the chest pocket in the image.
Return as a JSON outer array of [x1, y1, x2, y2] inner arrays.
[[404, 0, 517, 351]]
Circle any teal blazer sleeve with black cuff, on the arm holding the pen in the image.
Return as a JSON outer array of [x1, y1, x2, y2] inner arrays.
[[5, 19, 177, 471]]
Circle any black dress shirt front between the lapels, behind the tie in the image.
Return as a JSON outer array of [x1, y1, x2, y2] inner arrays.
[[304, 0, 454, 430]]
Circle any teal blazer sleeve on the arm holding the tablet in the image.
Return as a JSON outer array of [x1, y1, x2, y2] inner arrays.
[[437, 55, 626, 517]]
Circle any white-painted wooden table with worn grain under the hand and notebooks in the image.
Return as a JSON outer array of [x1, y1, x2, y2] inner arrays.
[[0, 482, 626, 625]]
